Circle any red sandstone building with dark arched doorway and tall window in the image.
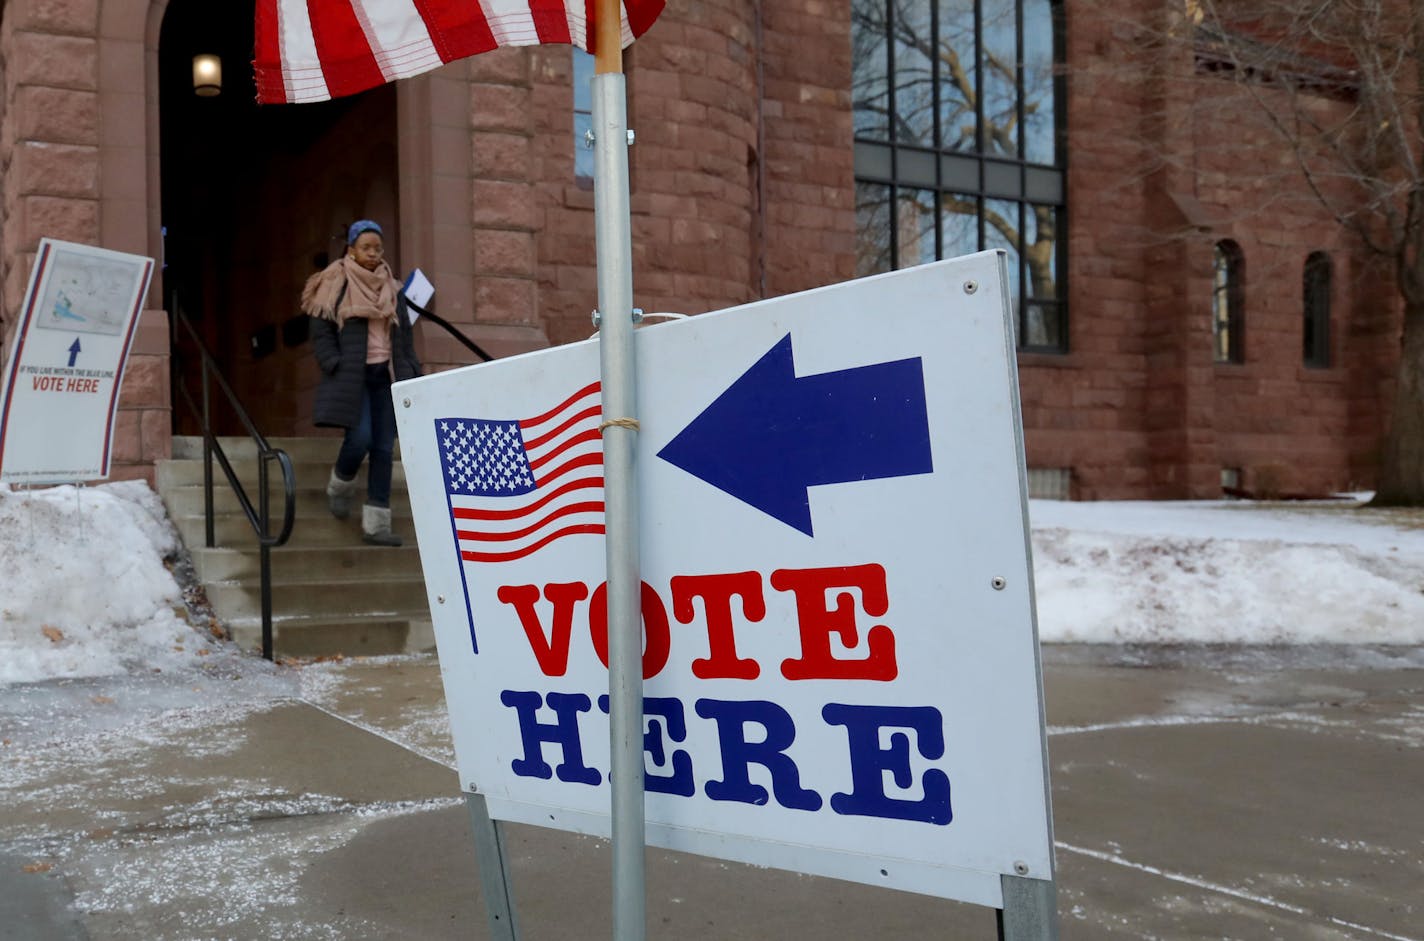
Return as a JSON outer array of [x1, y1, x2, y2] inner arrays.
[[0, 0, 1400, 498]]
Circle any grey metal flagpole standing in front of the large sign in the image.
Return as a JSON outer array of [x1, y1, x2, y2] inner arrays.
[[592, 0, 646, 941]]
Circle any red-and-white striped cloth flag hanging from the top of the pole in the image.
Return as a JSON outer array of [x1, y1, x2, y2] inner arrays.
[[252, 0, 665, 104]]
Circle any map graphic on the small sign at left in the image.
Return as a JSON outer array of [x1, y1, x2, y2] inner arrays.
[[34, 249, 144, 336]]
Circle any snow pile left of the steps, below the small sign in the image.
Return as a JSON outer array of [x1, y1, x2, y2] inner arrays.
[[0, 481, 211, 683]]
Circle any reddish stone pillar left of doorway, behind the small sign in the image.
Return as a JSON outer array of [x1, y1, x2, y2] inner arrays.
[[0, 0, 171, 483]]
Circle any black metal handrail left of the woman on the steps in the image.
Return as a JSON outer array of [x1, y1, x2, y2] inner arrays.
[[169, 300, 296, 661]]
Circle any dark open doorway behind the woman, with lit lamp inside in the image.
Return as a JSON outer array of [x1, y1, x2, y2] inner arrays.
[[158, 0, 400, 436]]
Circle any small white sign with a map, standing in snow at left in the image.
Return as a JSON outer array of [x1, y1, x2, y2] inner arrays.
[[0, 239, 154, 484]]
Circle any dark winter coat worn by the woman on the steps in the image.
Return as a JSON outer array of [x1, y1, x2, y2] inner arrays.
[[302, 261, 420, 429]]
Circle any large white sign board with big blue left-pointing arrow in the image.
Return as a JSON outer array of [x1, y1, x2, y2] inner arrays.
[[394, 252, 1052, 907]]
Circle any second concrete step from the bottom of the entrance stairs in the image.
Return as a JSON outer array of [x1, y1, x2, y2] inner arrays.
[[205, 572, 430, 624]]
